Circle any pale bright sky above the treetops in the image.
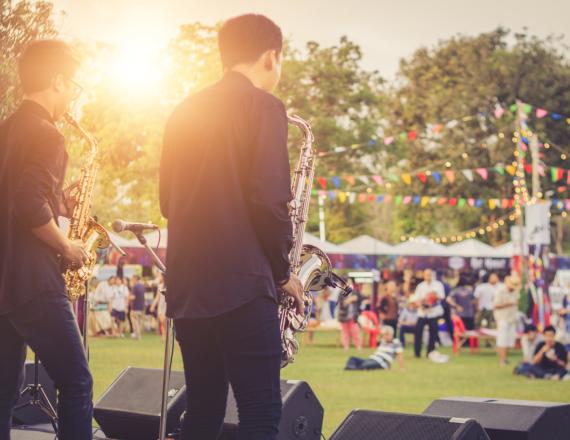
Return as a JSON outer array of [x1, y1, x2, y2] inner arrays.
[[53, 0, 570, 78]]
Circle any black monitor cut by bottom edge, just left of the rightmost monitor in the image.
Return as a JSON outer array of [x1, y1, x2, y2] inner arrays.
[[330, 409, 489, 440]]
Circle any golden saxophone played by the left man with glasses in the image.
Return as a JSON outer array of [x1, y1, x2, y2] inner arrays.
[[63, 113, 111, 301]]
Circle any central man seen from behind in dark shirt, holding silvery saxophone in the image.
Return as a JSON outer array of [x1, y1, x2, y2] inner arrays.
[[160, 14, 304, 440]]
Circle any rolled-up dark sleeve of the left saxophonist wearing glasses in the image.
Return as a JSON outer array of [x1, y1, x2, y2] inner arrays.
[[15, 130, 65, 228]]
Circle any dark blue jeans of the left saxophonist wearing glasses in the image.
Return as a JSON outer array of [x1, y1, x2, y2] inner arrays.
[[0, 292, 93, 440]]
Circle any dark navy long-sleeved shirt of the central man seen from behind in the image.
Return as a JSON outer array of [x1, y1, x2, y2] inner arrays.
[[160, 71, 292, 318]]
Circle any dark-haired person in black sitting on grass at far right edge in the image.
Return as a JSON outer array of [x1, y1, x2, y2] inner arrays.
[[529, 325, 568, 380]]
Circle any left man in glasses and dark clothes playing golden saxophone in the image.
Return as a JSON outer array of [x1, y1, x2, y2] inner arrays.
[[0, 40, 92, 440]]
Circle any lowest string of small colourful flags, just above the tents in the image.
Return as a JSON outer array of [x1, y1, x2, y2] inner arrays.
[[312, 190, 570, 211]]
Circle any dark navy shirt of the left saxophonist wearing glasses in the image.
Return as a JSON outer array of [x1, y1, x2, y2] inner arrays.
[[0, 101, 67, 315]]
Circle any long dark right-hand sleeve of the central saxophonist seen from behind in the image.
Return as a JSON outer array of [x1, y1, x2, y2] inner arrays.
[[250, 98, 293, 282]]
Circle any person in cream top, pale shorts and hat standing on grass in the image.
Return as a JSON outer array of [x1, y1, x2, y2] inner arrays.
[[493, 274, 521, 365]]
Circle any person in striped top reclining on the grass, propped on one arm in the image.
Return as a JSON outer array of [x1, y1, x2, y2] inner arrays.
[[345, 325, 404, 370]]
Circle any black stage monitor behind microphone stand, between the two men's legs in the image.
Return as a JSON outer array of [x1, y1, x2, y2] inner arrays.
[[93, 367, 186, 440]]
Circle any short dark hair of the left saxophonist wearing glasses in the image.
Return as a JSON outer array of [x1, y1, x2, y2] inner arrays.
[[18, 40, 80, 93]]
